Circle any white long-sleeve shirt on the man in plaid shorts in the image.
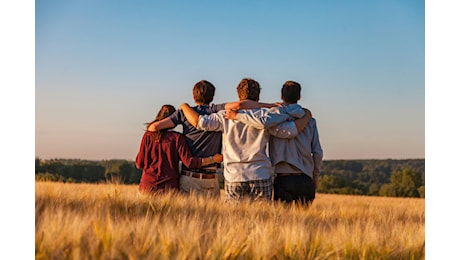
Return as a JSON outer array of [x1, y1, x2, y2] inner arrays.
[[197, 108, 297, 182]]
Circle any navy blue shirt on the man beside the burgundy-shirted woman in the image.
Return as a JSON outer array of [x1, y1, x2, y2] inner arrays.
[[169, 104, 225, 157]]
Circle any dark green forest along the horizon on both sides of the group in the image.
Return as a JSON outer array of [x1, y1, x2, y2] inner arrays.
[[35, 158, 425, 198]]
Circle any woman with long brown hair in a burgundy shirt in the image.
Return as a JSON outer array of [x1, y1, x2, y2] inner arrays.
[[136, 105, 222, 193]]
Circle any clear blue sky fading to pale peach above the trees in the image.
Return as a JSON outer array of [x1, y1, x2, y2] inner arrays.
[[35, 0, 425, 160]]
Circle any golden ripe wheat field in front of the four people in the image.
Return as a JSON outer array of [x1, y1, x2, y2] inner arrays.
[[35, 182, 425, 259]]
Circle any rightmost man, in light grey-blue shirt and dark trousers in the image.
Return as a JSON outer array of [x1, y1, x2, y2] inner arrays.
[[230, 81, 323, 205]]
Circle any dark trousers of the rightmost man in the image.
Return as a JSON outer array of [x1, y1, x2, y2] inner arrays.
[[273, 174, 315, 205]]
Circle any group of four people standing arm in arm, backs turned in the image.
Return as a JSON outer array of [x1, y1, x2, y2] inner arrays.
[[136, 78, 323, 204]]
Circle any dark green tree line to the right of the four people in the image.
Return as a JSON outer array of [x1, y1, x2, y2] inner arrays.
[[318, 159, 425, 198]]
